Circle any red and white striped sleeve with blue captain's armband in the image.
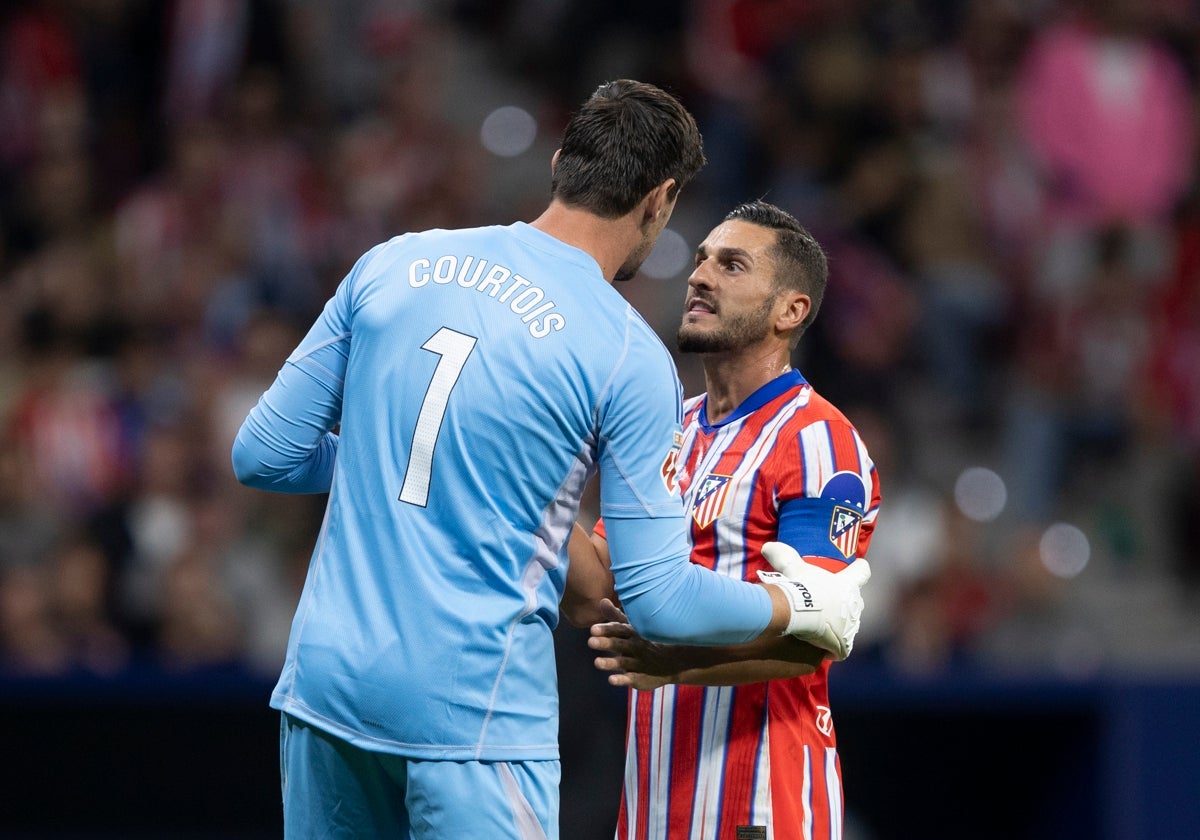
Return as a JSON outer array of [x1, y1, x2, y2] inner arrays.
[[776, 420, 880, 571]]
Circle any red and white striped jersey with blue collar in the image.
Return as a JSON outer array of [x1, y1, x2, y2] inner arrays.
[[617, 371, 880, 840]]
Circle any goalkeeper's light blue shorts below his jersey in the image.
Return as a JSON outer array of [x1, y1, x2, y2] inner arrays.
[[280, 714, 560, 840]]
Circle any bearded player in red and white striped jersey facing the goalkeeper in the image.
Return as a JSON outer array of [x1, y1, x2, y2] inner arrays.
[[571, 202, 880, 840]]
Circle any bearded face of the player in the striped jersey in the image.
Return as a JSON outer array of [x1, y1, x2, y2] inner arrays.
[[677, 221, 775, 353]]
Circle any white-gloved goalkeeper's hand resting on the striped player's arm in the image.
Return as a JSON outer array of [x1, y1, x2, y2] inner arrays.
[[758, 542, 871, 661]]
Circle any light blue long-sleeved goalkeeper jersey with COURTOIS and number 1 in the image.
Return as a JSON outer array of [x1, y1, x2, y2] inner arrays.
[[233, 223, 770, 761]]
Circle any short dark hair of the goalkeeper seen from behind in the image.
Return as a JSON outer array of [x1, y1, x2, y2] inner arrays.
[[551, 79, 704, 218]]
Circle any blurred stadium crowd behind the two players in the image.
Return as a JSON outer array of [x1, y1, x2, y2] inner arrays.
[[0, 0, 1200, 677]]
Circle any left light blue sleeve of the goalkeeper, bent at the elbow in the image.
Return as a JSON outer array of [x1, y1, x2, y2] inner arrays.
[[225, 246, 371, 493]]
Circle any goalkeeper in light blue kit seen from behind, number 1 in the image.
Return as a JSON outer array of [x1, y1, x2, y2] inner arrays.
[[233, 80, 860, 840]]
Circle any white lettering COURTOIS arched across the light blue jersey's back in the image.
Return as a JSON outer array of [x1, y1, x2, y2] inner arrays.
[[408, 254, 566, 338]]
